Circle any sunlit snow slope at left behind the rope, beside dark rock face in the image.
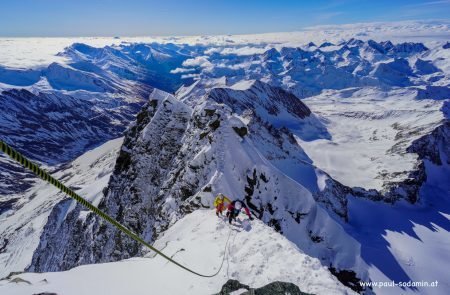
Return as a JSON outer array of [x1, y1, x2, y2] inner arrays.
[[0, 138, 123, 277]]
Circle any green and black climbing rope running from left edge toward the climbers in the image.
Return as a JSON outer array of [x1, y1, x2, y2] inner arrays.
[[0, 140, 231, 278]]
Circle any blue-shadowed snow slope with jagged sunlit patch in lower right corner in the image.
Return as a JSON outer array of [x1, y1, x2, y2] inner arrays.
[[347, 155, 450, 294]]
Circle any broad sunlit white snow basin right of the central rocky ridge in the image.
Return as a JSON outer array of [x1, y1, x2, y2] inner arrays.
[[299, 88, 446, 190]]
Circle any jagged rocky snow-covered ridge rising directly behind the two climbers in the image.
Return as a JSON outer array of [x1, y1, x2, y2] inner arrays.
[[30, 82, 448, 294]]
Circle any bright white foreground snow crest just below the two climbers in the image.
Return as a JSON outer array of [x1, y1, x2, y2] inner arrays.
[[0, 210, 354, 295]]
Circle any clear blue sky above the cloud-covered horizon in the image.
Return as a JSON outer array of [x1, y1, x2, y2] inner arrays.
[[0, 0, 450, 37]]
